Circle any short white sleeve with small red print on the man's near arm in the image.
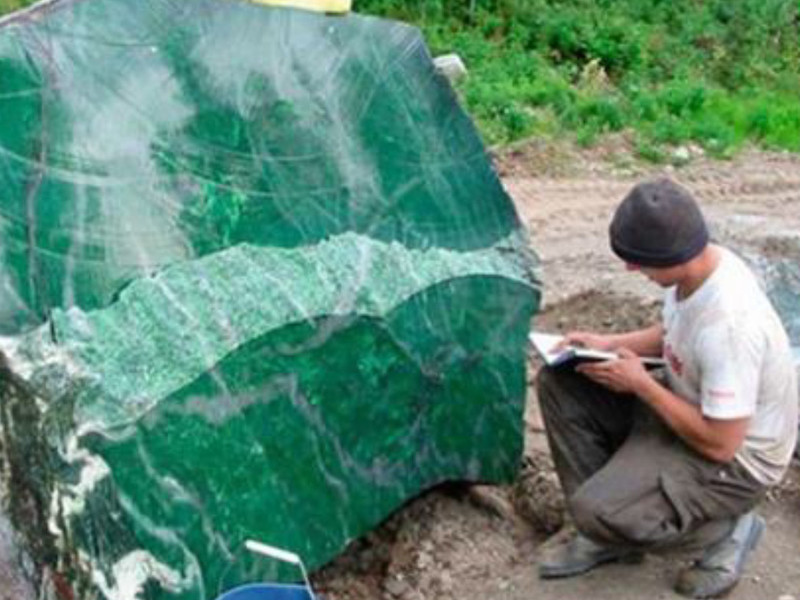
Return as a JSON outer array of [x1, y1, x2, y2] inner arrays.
[[697, 320, 766, 420]]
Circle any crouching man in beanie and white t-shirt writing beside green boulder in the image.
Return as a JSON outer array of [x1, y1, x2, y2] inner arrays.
[[537, 179, 798, 598]]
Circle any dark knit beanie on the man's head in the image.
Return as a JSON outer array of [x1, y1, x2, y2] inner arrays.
[[608, 179, 708, 267]]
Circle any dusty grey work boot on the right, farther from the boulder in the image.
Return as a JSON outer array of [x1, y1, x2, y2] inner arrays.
[[675, 511, 766, 598]]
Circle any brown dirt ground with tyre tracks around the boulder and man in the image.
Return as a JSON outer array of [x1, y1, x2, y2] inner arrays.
[[313, 137, 800, 600]]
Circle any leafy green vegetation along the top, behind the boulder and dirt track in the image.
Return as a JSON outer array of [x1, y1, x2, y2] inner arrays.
[[0, 0, 800, 160]]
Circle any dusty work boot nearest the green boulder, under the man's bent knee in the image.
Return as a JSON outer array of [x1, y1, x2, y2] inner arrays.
[[539, 532, 643, 579]]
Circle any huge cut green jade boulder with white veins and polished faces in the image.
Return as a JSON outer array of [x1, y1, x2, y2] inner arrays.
[[0, 0, 539, 600]]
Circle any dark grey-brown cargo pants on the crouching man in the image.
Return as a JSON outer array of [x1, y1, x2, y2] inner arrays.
[[537, 367, 766, 550]]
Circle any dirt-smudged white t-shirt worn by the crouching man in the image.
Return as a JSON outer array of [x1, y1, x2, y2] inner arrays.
[[663, 248, 798, 485]]
